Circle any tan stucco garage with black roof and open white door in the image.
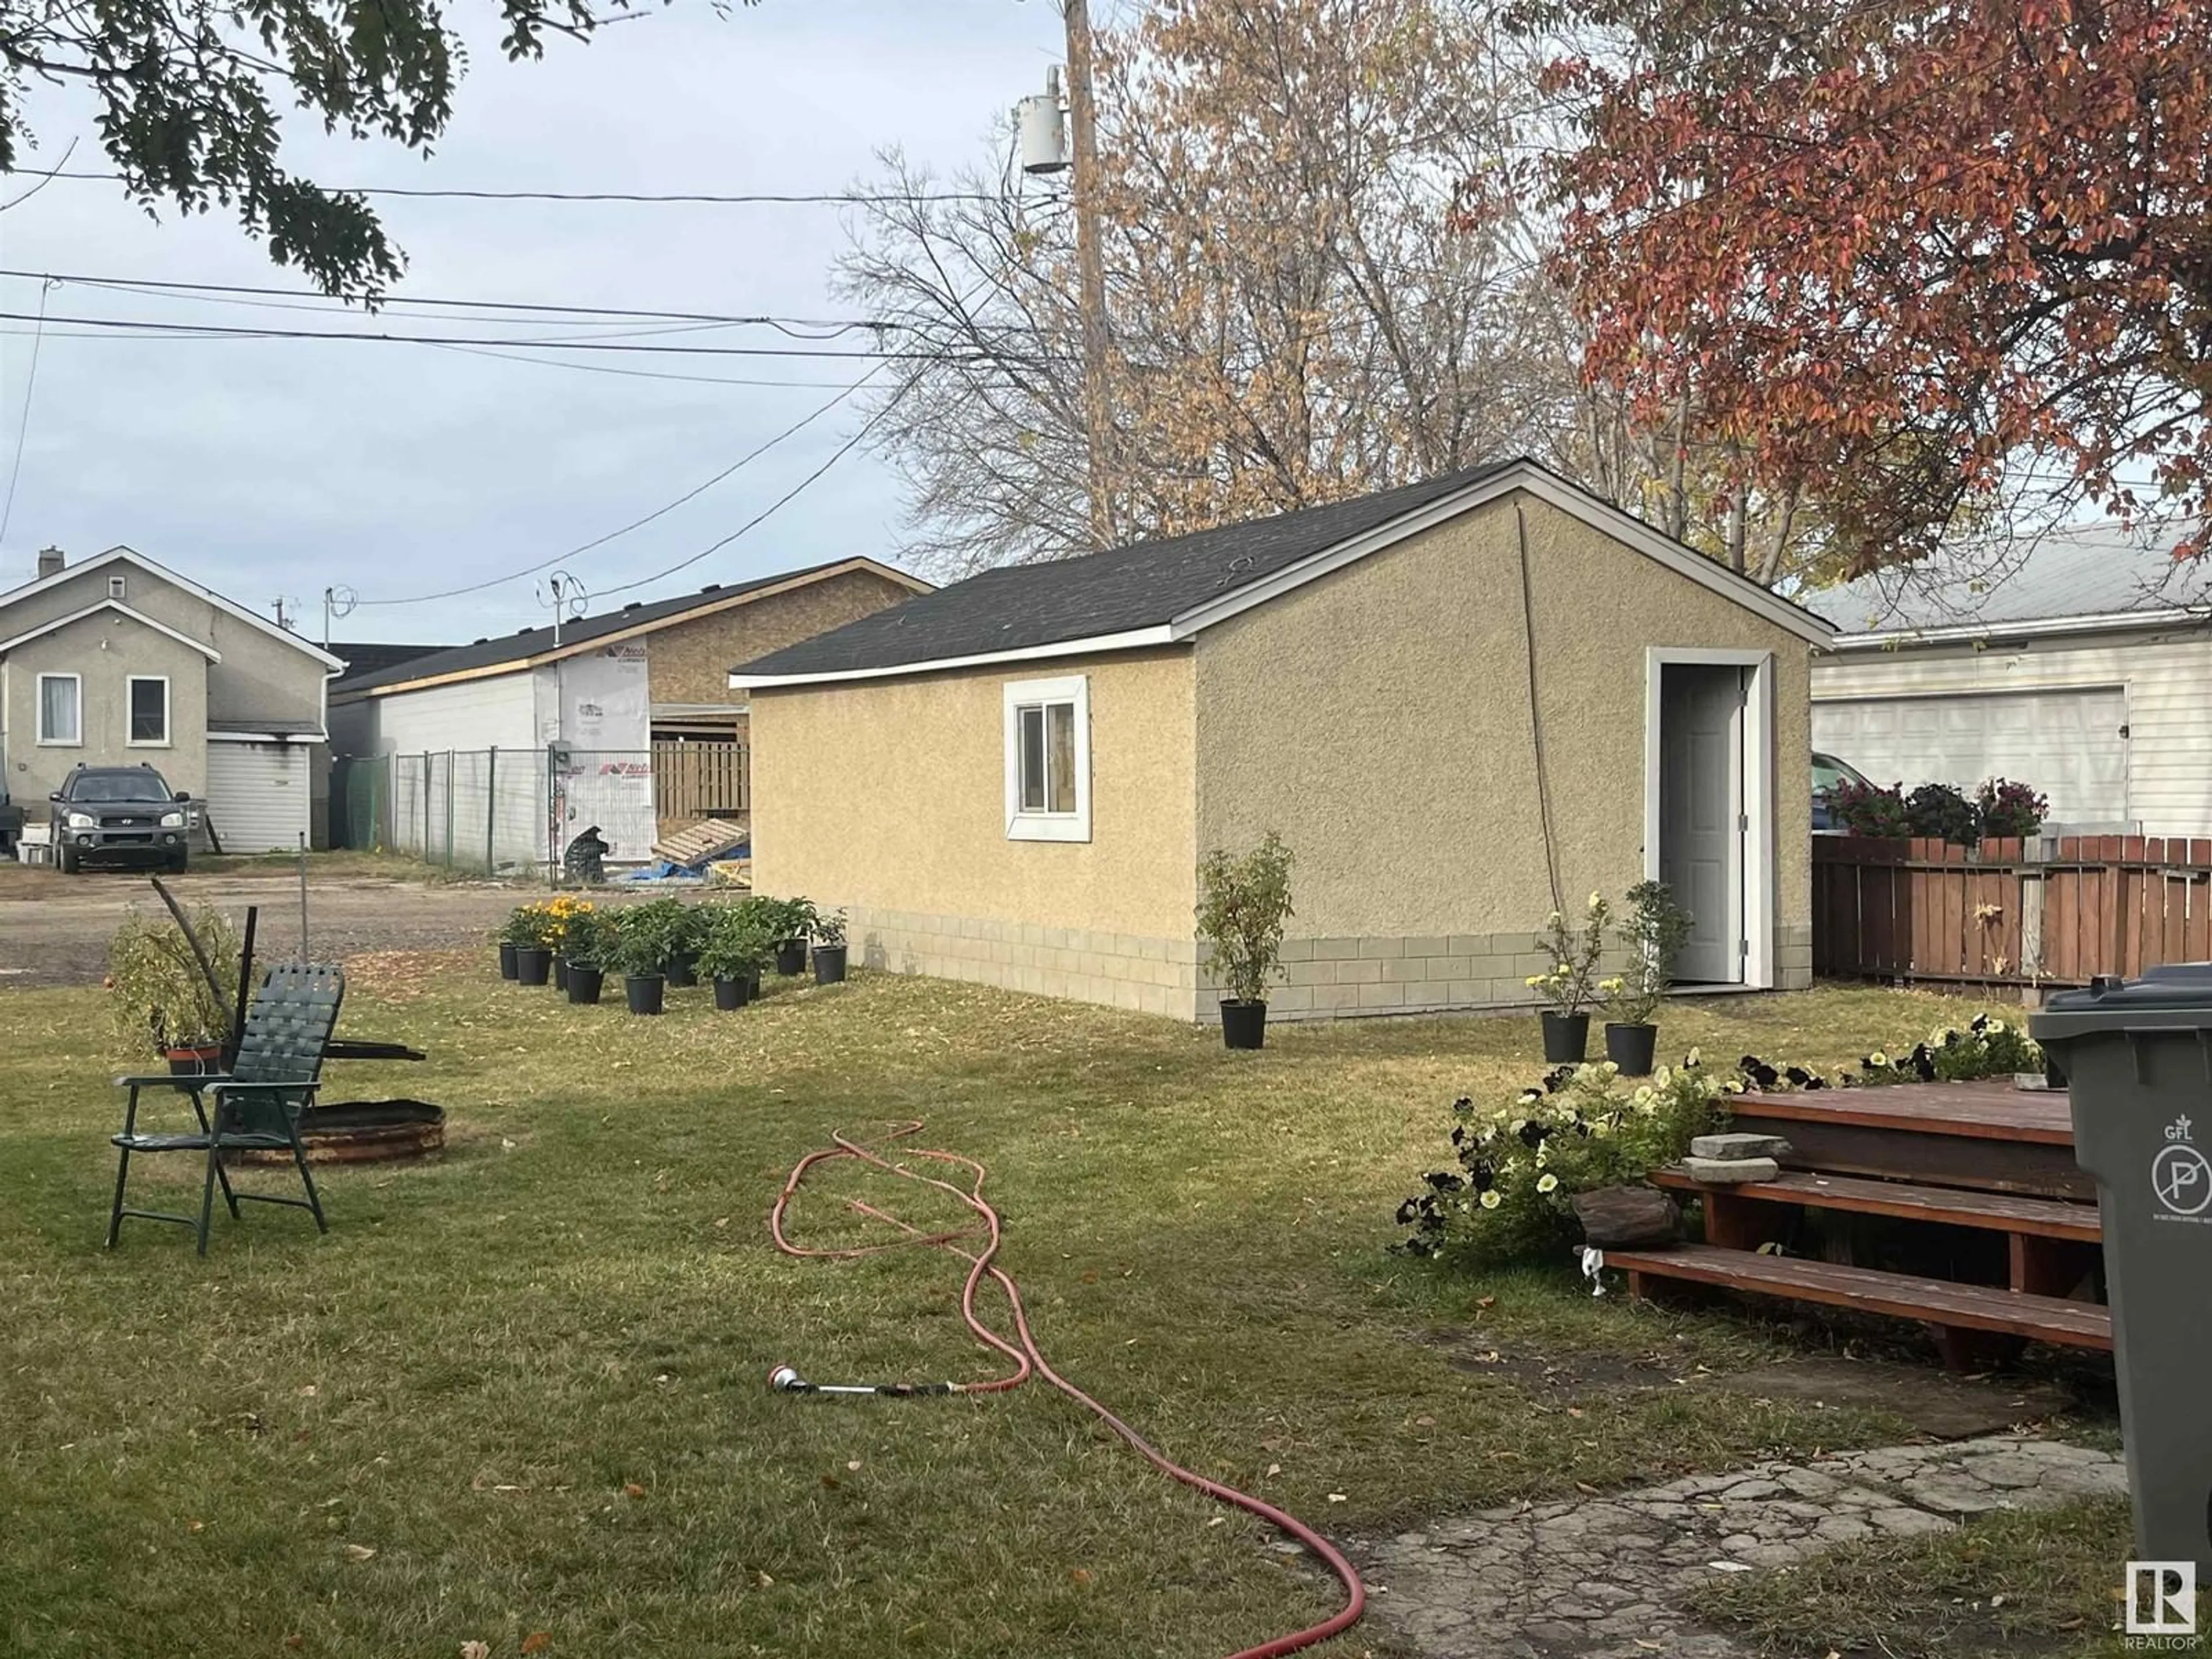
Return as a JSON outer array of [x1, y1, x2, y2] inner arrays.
[[730, 460, 1830, 1017]]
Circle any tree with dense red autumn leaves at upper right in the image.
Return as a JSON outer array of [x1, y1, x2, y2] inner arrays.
[[1551, 0, 2212, 573]]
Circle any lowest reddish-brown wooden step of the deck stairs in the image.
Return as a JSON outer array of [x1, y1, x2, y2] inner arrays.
[[1606, 1245, 2112, 1351]]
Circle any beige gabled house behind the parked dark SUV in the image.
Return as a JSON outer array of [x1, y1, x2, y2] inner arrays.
[[0, 546, 340, 851]]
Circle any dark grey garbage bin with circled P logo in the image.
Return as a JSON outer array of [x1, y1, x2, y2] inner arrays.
[[2028, 962, 2212, 1582]]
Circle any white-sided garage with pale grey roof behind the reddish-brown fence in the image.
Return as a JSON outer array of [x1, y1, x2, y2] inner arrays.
[[1809, 524, 2212, 836]]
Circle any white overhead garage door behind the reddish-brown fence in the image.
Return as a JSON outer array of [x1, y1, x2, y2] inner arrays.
[[1812, 685, 2128, 823]]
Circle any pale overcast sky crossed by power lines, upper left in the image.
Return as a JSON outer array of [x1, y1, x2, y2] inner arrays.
[[0, 0, 1059, 642]]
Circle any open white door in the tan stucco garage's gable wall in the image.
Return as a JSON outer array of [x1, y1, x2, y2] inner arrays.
[[1659, 661, 1749, 984]]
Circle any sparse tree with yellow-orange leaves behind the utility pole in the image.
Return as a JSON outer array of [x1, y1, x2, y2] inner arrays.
[[840, 0, 1590, 573]]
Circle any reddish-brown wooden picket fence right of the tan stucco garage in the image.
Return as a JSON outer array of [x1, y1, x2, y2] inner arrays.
[[1812, 836, 2212, 987]]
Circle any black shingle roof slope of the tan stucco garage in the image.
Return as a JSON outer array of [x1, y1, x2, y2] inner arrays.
[[732, 460, 1522, 675]]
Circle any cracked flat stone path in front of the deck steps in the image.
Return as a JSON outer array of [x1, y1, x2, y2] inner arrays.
[[1354, 1435, 2128, 1659]]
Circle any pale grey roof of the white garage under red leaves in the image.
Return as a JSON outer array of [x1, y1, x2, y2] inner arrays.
[[1805, 524, 2212, 635]]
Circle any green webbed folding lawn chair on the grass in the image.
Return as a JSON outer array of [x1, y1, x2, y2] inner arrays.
[[108, 964, 345, 1256]]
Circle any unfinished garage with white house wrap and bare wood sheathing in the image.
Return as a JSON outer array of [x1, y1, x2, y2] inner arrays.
[[329, 558, 929, 865]]
